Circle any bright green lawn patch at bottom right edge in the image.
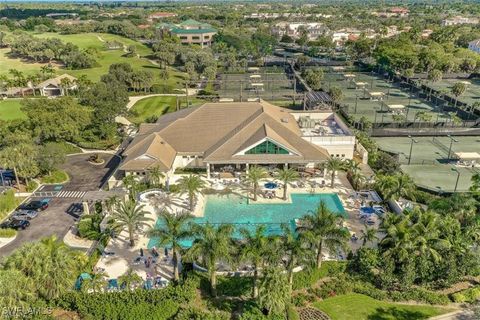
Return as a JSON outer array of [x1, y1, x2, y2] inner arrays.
[[314, 293, 451, 320]]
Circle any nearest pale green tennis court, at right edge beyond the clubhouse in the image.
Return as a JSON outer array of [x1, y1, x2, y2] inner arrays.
[[375, 137, 480, 192]]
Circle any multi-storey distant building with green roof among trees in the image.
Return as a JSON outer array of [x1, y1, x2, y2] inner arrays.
[[158, 19, 217, 48]]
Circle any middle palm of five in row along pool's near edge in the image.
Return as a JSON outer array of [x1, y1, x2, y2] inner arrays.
[[240, 225, 274, 299]]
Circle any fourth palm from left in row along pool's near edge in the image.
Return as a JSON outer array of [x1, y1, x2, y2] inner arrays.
[[280, 224, 312, 290]]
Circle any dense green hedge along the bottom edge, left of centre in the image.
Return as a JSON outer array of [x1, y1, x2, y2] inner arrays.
[[57, 279, 198, 320]]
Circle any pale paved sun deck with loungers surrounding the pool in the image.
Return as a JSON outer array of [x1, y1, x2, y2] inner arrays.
[[96, 173, 372, 279]]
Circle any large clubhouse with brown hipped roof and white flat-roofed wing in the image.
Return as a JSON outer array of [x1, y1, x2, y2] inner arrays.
[[119, 101, 355, 178]]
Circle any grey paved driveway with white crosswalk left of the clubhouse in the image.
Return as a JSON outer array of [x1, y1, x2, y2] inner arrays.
[[0, 154, 120, 256]]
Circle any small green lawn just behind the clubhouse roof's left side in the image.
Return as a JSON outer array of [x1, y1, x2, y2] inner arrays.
[[128, 96, 203, 124]]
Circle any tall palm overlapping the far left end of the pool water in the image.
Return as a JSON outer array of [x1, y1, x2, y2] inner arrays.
[[148, 210, 192, 281]]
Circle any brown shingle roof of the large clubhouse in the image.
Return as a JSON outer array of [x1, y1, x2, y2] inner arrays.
[[121, 101, 329, 170]]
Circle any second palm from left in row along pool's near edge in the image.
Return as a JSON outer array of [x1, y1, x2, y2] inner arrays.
[[185, 222, 233, 297]]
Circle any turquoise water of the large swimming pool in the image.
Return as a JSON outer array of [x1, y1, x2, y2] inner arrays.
[[148, 193, 346, 248]]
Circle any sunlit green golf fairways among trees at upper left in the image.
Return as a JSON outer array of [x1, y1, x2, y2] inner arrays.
[[0, 32, 184, 88]]
